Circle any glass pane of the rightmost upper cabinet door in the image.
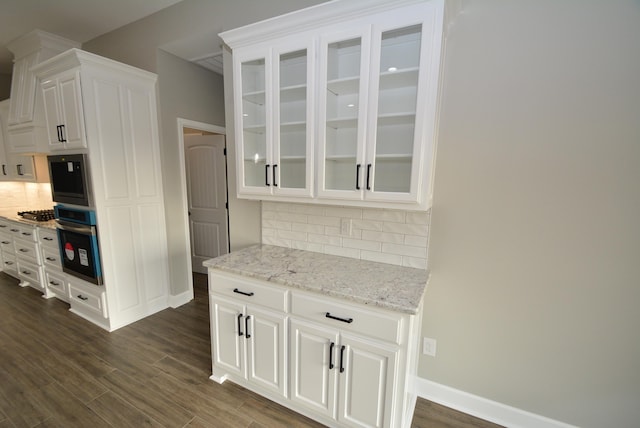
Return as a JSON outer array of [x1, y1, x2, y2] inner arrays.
[[367, 25, 422, 194]]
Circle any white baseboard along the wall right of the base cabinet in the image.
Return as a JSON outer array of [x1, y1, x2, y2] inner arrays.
[[414, 377, 576, 428]]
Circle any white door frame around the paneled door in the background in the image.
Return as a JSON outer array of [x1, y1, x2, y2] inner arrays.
[[178, 117, 226, 278]]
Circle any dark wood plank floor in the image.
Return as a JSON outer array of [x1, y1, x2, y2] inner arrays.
[[0, 272, 497, 428]]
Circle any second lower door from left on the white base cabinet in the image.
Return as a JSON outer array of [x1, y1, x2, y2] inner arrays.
[[245, 307, 286, 396]]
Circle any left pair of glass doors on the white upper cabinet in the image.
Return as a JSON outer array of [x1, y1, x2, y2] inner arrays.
[[234, 41, 314, 197]]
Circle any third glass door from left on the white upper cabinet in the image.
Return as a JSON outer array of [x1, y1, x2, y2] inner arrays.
[[318, 31, 369, 198]]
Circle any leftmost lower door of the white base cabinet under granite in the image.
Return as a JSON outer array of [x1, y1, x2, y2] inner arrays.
[[209, 296, 245, 377]]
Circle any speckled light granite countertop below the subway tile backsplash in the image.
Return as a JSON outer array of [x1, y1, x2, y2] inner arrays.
[[204, 245, 429, 314]]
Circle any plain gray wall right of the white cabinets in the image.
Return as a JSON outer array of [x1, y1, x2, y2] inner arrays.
[[419, 0, 640, 428]]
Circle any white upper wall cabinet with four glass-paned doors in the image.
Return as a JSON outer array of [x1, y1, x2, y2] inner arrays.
[[221, 0, 444, 210]]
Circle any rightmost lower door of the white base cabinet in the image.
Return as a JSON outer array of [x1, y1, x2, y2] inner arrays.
[[338, 335, 398, 427]]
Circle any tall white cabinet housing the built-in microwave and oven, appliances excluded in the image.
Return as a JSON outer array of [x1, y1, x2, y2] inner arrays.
[[33, 49, 169, 331]]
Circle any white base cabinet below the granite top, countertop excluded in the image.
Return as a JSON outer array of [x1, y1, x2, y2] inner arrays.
[[209, 269, 419, 427]]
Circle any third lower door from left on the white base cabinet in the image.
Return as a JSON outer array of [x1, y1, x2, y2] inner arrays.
[[290, 319, 338, 418]]
